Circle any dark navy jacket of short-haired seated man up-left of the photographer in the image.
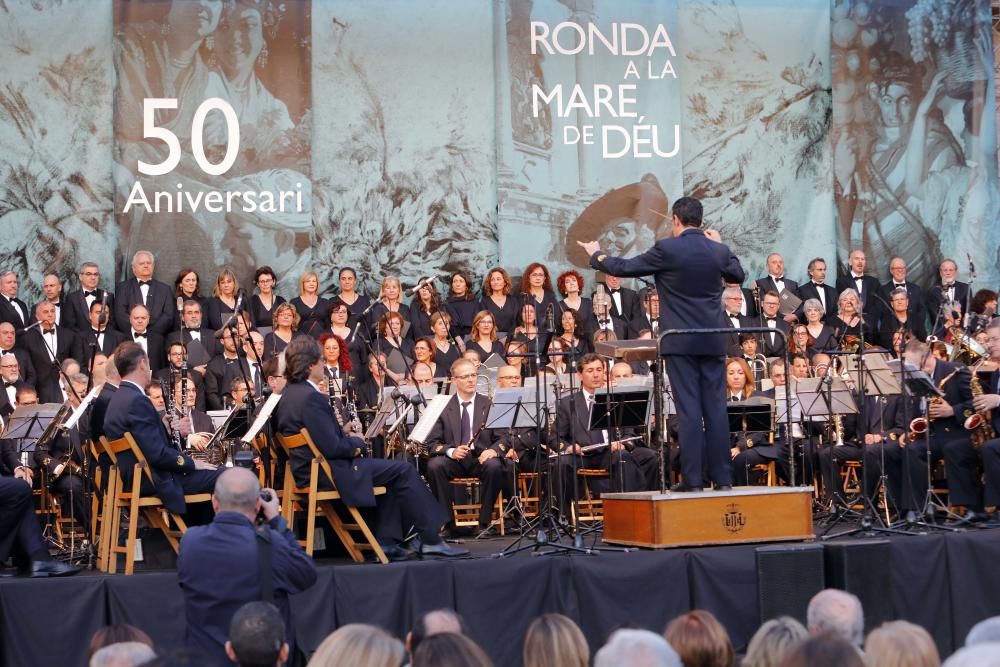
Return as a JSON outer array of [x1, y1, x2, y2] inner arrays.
[[103, 382, 201, 514]]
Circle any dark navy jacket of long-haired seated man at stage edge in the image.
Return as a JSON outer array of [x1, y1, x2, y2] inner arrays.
[[273, 382, 375, 507]]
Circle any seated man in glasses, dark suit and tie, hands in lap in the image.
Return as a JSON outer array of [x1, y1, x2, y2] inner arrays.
[[427, 360, 514, 530]]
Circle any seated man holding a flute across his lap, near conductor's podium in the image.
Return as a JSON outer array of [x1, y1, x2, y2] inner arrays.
[[552, 354, 657, 512]]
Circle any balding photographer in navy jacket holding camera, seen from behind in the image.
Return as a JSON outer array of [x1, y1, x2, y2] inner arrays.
[[177, 468, 316, 666]]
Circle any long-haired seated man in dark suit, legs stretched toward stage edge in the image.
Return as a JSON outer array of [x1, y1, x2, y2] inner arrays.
[[273, 336, 468, 558]]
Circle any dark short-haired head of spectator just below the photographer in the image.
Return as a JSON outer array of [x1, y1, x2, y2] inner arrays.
[[226, 601, 288, 667]]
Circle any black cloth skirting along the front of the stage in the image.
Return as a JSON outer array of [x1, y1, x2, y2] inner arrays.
[[0, 527, 1000, 666]]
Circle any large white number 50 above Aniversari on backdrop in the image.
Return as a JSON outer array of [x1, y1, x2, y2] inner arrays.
[[139, 97, 240, 176]]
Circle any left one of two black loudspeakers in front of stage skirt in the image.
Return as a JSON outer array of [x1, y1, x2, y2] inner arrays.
[[757, 544, 823, 625]]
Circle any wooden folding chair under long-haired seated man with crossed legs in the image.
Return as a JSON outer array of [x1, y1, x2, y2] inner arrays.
[[275, 429, 389, 563]]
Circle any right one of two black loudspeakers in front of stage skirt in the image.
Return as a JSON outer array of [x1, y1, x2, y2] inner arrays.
[[824, 540, 896, 633]]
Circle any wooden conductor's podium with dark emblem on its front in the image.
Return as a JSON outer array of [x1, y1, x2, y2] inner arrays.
[[601, 486, 814, 549]]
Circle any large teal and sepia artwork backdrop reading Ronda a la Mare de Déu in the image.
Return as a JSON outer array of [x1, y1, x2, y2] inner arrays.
[[0, 0, 1000, 300]]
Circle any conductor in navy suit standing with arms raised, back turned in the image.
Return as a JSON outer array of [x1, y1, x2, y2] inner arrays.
[[578, 197, 746, 491]]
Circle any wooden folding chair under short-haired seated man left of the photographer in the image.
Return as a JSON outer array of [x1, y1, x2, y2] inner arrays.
[[101, 433, 212, 575]]
